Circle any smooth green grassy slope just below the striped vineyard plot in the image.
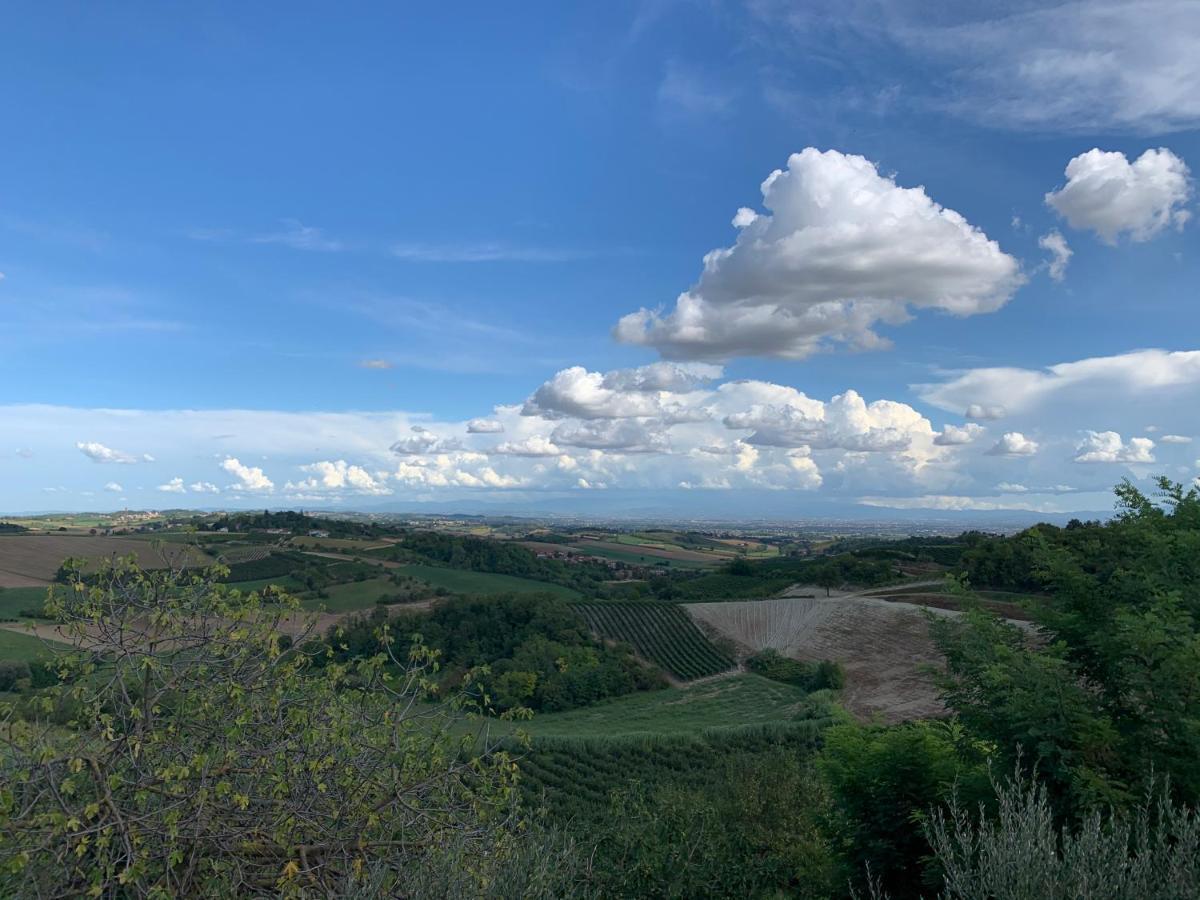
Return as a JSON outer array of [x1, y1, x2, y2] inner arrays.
[[498, 672, 810, 738]]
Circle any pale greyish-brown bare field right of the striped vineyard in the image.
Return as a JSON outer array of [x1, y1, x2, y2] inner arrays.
[[684, 600, 954, 722]]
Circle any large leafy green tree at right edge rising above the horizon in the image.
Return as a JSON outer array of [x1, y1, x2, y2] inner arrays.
[[935, 480, 1200, 810]]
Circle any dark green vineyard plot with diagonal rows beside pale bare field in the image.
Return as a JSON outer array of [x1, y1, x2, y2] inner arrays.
[[576, 602, 734, 682]]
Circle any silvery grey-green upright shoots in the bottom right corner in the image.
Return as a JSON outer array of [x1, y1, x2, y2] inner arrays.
[[925, 769, 1200, 900]]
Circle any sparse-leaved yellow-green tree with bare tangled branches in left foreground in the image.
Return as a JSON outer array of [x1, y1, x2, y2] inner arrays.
[[0, 560, 564, 898]]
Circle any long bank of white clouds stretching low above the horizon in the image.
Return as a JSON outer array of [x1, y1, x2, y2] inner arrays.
[[18, 340, 1200, 515]]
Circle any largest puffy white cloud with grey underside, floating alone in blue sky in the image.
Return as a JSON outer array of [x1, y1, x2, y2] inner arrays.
[[616, 148, 1024, 360]]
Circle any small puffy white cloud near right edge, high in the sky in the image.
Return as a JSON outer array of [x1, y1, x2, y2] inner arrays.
[[1045, 150, 1185, 244]]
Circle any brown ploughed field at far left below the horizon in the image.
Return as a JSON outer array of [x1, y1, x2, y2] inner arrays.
[[0, 534, 205, 588]]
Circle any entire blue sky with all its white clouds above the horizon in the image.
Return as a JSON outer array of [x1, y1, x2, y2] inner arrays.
[[0, 0, 1200, 511]]
